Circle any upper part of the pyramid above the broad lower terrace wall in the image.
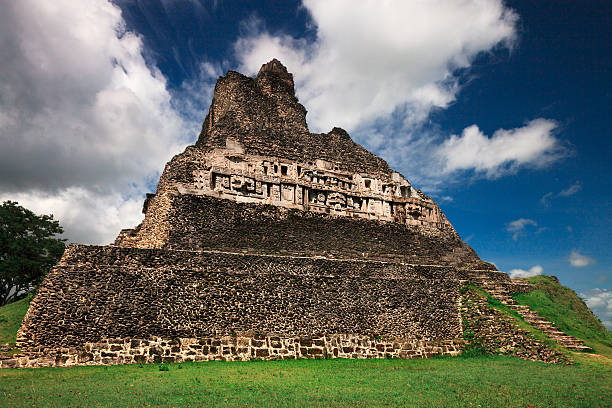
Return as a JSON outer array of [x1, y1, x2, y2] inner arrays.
[[115, 60, 468, 255]]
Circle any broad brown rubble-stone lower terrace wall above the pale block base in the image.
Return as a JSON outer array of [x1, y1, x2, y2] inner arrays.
[[17, 246, 461, 349]]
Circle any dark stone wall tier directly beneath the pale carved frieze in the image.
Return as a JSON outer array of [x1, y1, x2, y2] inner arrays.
[[116, 195, 495, 270]]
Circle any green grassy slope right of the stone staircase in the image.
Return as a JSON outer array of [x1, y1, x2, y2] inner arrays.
[[514, 276, 612, 357]]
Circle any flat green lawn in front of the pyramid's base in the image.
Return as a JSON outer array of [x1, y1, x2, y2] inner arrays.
[[0, 356, 612, 407]]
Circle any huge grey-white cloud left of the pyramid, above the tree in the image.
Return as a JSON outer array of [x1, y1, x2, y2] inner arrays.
[[0, 0, 186, 243]]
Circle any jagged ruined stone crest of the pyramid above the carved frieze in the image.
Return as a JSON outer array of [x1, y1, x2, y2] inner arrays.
[[195, 60, 391, 175]]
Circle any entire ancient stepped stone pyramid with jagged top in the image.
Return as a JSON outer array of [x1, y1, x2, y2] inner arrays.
[[0, 60, 584, 367]]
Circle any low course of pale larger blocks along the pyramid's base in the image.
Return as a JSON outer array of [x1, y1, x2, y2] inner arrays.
[[0, 334, 463, 368]]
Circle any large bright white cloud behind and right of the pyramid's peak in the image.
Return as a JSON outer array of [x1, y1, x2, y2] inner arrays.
[[236, 0, 518, 131]]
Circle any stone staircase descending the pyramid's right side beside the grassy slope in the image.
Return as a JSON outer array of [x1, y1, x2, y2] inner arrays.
[[470, 271, 593, 351]]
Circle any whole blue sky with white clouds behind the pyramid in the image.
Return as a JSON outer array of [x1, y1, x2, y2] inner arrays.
[[0, 0, 612, 327]]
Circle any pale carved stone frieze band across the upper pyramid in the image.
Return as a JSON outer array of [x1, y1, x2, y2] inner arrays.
[[178, 143, 450, 228]]
